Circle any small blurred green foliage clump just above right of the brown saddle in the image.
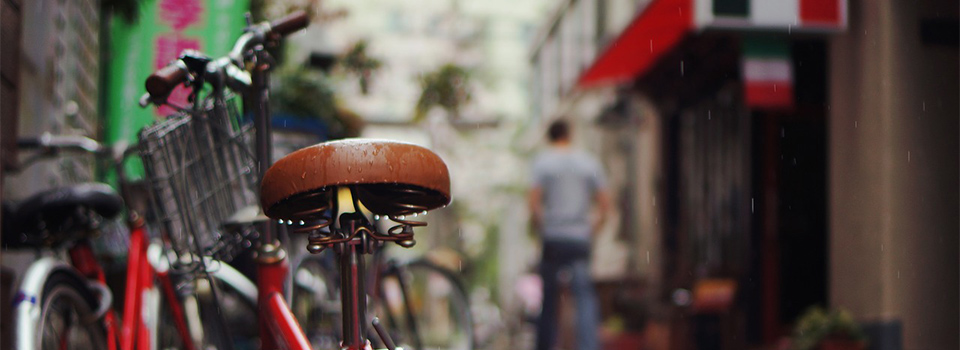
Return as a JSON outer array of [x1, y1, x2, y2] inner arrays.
[[413, 63, 470, 122]]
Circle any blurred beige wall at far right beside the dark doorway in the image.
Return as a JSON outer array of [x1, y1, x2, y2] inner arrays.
[[829, 0, 960, 349]]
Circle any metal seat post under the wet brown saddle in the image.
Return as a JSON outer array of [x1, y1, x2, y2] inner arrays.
[[334, 220, 367, 350]]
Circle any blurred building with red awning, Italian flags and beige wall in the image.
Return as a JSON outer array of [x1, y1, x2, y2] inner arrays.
[[531, 0, 960, 349]]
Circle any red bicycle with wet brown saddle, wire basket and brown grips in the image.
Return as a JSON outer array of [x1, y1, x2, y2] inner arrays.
[[143, 9, 469, 350]]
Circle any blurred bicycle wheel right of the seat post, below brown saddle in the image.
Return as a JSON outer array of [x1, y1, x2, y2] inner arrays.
[[375, 260, 474, 350]]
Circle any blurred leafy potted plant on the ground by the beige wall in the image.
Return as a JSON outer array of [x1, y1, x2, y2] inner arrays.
[[790, 306, 867, 350]]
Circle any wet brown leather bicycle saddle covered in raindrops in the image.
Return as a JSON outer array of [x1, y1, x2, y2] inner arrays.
[[260, 139, 450, 220]]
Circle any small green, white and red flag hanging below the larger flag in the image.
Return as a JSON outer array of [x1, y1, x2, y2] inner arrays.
[[740, 38, 794, 109]]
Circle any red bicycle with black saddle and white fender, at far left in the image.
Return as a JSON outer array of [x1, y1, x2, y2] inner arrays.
[[2, 134, 256, 350]]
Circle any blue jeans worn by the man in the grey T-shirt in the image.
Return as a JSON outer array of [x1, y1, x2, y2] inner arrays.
[[537, 241, 600, 350]]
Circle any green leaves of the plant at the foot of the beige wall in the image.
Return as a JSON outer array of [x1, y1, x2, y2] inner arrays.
[[791, 306, 866, 350]]
